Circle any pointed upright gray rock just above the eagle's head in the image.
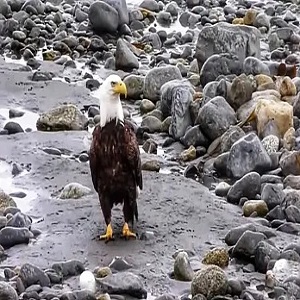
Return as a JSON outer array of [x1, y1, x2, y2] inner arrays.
[[115, 38, 139, 71]]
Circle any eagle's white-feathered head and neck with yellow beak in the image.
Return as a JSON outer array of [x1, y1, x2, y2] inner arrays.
[[99, 74, 127, 127]]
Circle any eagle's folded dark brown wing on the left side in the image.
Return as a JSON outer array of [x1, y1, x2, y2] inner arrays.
[[89, 126, 101, 192]]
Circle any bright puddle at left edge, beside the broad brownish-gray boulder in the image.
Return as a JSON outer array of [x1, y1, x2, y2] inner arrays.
[[0, 108, 39, 131]]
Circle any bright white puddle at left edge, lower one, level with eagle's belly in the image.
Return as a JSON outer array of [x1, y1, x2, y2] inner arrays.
[[0, 160, 37, 213]]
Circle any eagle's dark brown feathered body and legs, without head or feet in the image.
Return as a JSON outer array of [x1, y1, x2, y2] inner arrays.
[[90, 119, 143, 231]]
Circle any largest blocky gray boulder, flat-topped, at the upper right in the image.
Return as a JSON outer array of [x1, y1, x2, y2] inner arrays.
[[195, 22, 260, 69]]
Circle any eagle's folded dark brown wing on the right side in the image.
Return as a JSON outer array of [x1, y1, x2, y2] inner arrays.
[[124, 121, 143, 190]]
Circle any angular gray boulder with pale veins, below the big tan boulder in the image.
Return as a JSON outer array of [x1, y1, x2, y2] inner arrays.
[[227, 132, 272, 178]]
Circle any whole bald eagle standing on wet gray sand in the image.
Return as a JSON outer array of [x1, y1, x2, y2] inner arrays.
[[90, 75, 143, 242]]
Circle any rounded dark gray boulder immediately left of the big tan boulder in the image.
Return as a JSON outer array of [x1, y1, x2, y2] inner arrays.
[[196, 96, 237, 140]]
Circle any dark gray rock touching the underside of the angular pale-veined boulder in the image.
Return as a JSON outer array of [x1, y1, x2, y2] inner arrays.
[[227, 172, 261, 204]]
